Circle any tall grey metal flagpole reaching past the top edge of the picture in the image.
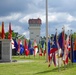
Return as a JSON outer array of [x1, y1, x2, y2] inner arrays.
[[46, 0, 48, 62]]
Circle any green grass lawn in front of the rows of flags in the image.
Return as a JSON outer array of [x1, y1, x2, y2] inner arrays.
[[0, 56, 76, 75]]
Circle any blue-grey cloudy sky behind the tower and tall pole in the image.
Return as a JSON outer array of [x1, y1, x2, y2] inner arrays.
[[0, 0, 76, 38]]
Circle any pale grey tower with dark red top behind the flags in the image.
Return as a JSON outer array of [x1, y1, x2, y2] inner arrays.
[[28, 18, 41, 43]]
